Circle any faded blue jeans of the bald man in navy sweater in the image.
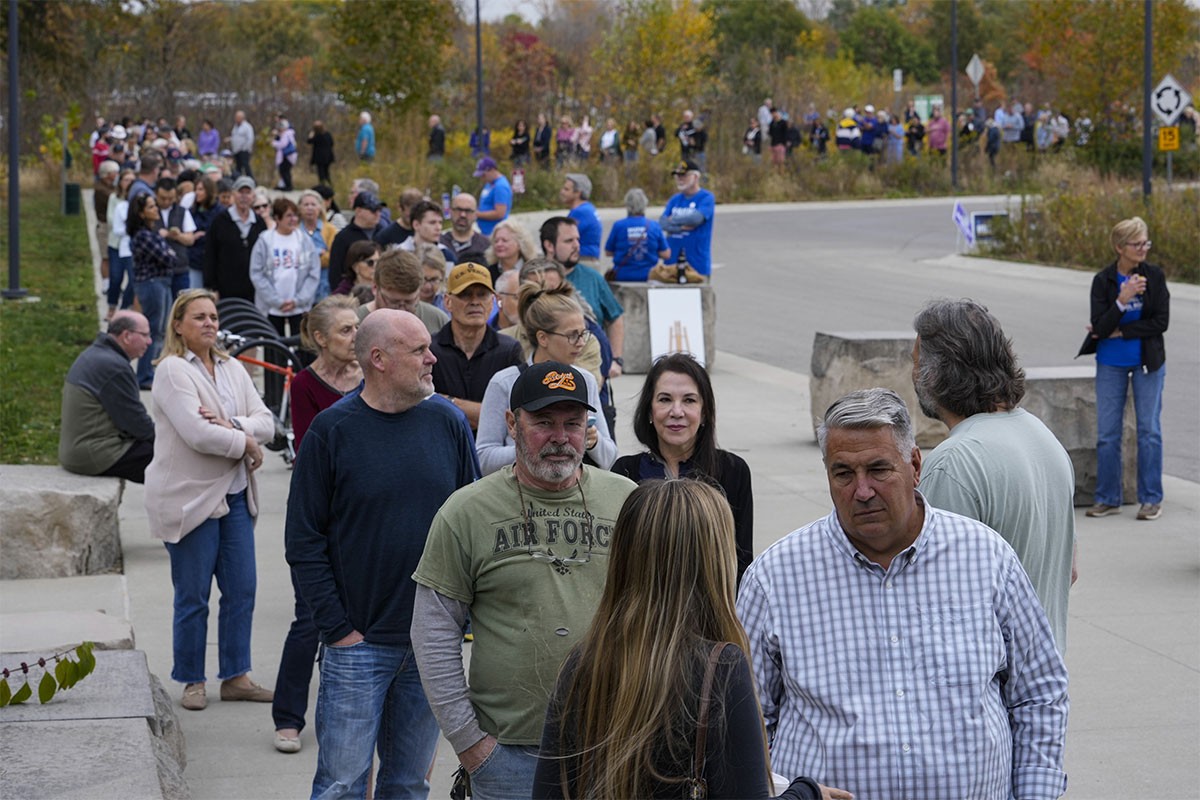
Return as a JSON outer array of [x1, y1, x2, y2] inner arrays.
[[312, 642, 438, 800]]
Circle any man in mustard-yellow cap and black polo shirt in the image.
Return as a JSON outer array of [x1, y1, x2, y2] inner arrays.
[[430, 261, 523, 431]]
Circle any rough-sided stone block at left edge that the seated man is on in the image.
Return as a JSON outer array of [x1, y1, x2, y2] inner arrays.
[[0, 464, 122, 578]]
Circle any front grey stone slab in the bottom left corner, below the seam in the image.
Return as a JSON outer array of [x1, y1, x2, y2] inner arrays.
[[0, 719, 163, 800]]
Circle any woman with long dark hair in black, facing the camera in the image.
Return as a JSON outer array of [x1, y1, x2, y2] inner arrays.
[[612, 353, 754, 583]]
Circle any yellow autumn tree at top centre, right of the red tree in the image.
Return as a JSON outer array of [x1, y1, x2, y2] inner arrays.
[[592, 0, 716, 119]]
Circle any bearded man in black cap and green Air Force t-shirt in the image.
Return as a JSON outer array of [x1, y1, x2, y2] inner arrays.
[[412, 361, 635, 800]]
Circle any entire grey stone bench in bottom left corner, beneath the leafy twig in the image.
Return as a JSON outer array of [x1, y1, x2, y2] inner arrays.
[[0, 650, 191, 800]]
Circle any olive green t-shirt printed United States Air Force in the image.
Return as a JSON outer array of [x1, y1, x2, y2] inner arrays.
[[413, 467, 635, 745]]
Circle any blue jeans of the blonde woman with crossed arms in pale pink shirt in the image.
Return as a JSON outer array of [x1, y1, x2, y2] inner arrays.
[[166, 492, 257, 684]]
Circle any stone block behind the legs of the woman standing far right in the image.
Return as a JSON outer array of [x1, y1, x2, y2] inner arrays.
[[1021, 365, 1138, 506]]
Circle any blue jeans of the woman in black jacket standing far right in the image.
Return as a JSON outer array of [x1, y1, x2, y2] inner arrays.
[[1096, 363, 1166, 506]]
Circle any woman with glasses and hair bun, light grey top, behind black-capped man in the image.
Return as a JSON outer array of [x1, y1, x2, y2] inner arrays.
[[475, 283, 617, 475]]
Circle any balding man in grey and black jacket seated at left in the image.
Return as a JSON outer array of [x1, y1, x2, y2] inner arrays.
[[59, 311, 154, 483]]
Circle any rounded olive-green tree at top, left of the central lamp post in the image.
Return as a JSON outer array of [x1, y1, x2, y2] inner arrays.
[[329, 0, 460, 112]]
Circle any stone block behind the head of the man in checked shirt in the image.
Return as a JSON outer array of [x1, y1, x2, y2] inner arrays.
[[809, 331, 948, 449]]
